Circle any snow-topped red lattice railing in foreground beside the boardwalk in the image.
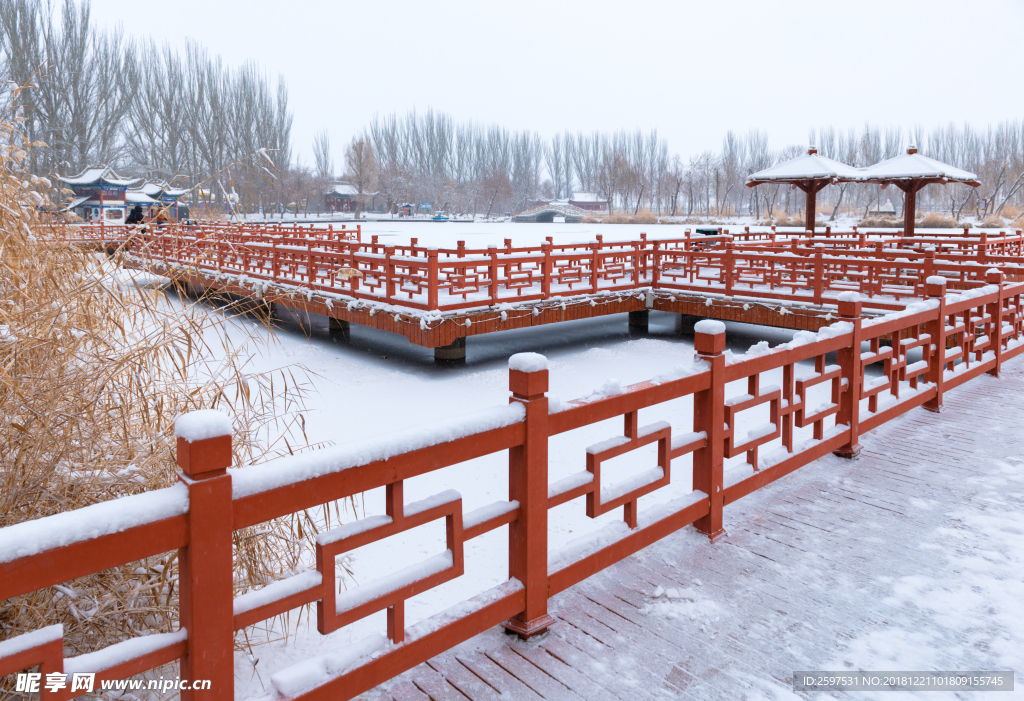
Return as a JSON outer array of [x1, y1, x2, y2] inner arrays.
[[0, 271, 1024, 699]]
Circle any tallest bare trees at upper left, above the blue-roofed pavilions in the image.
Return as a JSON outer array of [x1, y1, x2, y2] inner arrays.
[[0, 0, 292, 207]]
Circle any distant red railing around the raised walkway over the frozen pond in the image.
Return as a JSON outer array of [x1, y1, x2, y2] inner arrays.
[[112, 225, 1024, 312]]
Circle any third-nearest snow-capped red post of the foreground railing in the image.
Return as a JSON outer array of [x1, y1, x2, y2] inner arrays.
[[693, 319, 725, 540]]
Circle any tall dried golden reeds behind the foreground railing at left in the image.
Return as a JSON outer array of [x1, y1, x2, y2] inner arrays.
[[0, 114, 340, 654]]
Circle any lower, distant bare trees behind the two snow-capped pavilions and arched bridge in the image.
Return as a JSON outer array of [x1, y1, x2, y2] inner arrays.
[[325, 111, 1024, 219]]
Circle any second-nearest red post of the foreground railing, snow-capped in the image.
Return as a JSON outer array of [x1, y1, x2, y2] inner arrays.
[[505, 353, 554, 640]]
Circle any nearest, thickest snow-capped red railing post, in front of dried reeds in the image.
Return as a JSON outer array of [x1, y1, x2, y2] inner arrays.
[[174, 410, 234, 701]]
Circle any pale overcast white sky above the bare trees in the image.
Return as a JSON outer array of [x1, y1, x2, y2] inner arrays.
[[92, 0, 1024, 165]]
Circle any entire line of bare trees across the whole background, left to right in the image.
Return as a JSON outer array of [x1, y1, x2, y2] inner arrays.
[[0, 0, 1024, 219]]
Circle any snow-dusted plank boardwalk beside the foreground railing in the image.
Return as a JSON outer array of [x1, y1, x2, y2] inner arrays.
[[360, 361, 1024, 701]]
